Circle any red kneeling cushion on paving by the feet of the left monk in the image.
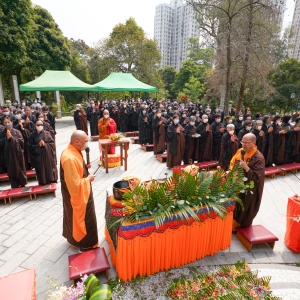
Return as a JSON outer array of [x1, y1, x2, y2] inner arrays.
[[68, 248, 110, 280]]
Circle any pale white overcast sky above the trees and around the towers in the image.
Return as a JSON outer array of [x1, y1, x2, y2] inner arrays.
[[32, 0, 295, 46]]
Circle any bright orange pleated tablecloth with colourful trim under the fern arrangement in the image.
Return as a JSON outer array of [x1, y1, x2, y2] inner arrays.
[[105, 202, 235, 281]]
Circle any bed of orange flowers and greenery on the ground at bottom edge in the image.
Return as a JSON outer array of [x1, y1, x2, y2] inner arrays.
[[167, 260, 280, 300]]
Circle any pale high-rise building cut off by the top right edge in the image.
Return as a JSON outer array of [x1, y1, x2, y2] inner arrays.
[[288, 0, 300, 61]]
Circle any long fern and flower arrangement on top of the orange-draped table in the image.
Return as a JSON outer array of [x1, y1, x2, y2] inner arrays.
[[110, 165, 253, 228]]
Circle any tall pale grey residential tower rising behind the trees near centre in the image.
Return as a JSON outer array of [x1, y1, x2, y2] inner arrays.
[[154, 0, 200, 70]]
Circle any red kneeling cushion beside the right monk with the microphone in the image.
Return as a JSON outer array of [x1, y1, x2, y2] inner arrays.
[[236, 225, 278, 244]]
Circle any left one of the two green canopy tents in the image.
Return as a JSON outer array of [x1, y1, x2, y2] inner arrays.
[[20, 70, 93, 92]]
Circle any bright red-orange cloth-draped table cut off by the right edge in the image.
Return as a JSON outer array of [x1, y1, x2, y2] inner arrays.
[[284, 197, 300, 253]]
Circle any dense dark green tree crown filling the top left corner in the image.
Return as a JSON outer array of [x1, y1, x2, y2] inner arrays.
[[0, 0, 33, 75]]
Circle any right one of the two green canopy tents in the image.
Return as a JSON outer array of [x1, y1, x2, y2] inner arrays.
[[93, 73, 157, 92]]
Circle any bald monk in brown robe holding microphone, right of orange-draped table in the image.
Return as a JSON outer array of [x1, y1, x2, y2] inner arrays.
[[230, 133, 265, 230]]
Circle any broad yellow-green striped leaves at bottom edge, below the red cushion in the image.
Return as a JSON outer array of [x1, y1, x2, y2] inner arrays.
[[79, 274, 111, 300]]
